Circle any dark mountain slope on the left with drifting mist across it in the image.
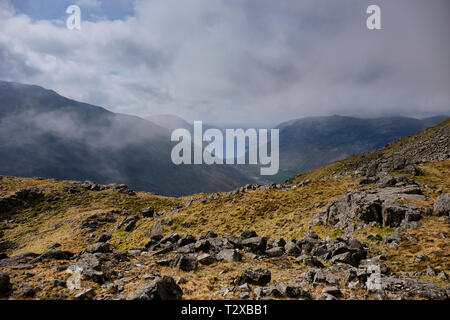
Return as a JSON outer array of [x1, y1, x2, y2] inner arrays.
[[0, 82, 253, 195]]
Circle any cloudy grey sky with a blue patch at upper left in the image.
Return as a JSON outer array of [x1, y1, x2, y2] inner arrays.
[[0, 0, 450, 127]]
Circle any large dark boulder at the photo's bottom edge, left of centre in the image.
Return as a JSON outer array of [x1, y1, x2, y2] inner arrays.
[[126, 276, 183, 300]]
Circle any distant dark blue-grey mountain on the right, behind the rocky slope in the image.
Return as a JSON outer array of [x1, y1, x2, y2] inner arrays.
[[273, 116, 447, 182]]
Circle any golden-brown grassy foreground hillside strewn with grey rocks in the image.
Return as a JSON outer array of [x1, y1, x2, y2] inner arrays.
[[0, 120, 450, 300]]
